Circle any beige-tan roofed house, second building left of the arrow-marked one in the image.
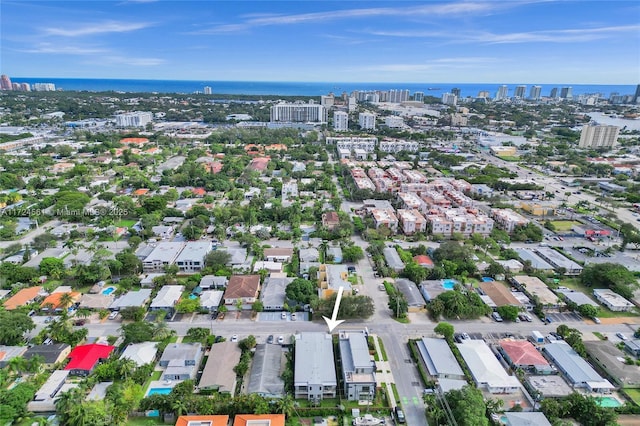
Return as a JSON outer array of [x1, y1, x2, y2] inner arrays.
[[198, 342, 242, 395]]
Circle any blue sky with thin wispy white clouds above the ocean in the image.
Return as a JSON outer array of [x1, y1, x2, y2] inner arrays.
[[0, 0, 640, 85]]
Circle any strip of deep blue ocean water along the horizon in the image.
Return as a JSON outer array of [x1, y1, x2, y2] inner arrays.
[[12, 77, 636, 97]]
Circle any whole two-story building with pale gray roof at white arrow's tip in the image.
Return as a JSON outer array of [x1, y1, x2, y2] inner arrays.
[[293, 333, 338, 401]]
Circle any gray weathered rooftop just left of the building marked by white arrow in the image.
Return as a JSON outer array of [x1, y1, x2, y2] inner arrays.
[[247, 344, 285, 397]]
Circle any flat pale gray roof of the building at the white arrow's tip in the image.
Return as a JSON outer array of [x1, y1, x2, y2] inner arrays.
[[294, 333, 337, 386]]
